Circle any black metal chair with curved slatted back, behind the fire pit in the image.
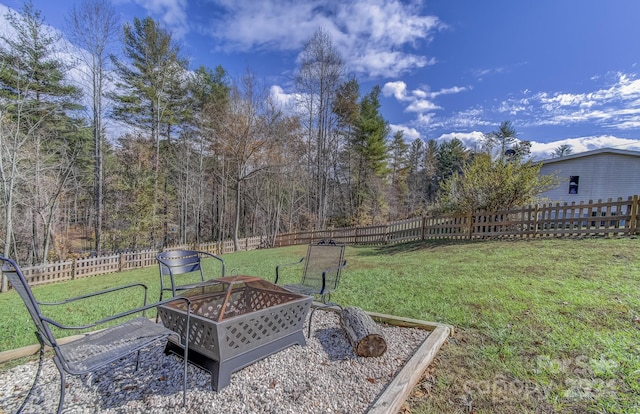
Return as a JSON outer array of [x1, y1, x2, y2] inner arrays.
[[156, 250, 224, 300]]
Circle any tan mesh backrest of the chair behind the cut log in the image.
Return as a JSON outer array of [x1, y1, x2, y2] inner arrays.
[[301, 240, 346, 293]]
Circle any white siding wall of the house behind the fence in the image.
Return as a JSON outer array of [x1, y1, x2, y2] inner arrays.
[[540, 149, 640, 204]]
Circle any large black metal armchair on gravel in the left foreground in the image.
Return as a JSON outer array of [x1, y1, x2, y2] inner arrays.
[[0, 256, 191, 413]]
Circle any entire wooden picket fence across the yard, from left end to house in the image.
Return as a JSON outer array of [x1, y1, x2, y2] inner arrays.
[[2, 195, 640, 285]]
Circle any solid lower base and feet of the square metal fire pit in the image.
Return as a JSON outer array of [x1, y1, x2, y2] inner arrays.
[[164, 331, 307, 391]]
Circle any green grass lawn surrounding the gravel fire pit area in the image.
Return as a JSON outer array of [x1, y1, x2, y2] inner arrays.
[[0, 239, 640, 413]]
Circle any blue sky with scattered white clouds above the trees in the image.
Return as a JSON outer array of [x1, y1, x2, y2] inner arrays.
[[0, 0, 640, 158]]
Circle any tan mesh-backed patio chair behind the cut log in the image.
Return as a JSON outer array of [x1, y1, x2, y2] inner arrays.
[[275, 240, 347, 337]]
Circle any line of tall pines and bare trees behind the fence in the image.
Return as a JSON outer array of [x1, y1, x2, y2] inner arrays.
[[0, 0, 548, 264]]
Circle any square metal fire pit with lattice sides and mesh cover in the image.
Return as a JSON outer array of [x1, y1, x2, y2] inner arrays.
[[158, 276, 312, 391]]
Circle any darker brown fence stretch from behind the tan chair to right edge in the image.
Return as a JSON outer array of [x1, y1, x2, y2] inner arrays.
[[275, 195, 640, 247]]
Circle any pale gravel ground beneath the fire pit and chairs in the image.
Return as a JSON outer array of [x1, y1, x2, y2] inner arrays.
[[0, 311, 429, 414]]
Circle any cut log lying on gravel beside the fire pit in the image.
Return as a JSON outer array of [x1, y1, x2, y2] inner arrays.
[[340, 307, 387, 357]]
